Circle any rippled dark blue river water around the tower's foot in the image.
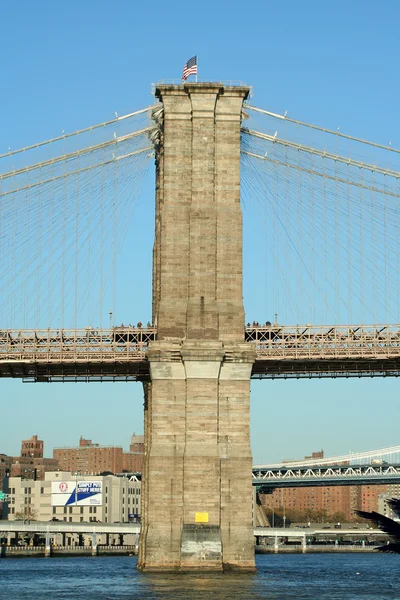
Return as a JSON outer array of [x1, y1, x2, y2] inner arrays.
[[0, 553, 400, 600]]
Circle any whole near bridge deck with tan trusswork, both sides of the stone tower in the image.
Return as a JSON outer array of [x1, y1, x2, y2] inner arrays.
[[0, 324, 400, 382]]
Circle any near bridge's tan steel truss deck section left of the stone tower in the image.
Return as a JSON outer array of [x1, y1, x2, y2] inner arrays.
[[0, 327, 156, 381]]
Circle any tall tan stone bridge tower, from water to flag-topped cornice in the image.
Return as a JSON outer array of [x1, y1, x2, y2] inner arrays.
[[139, 83, 255, 571]]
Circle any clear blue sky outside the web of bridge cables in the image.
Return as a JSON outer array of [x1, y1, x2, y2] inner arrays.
[[0, 0, 400, 463]]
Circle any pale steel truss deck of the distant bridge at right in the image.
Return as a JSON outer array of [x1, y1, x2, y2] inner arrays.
[[252, 464, 400, 491]]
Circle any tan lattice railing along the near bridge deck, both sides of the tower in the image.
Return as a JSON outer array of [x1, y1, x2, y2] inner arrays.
[[0, 324, 400, 362]]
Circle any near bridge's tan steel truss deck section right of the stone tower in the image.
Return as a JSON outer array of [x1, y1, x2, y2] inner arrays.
[[245, 325, 400, 379]]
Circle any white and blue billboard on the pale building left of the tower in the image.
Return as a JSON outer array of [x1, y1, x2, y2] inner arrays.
[[51, 481, 103, 506]]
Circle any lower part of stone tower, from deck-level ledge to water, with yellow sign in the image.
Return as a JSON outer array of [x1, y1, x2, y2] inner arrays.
[[138, 342, 255, 572]]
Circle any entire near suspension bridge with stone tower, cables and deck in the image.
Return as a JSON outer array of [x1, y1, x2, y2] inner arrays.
[[0, 82, 400, 571]]
